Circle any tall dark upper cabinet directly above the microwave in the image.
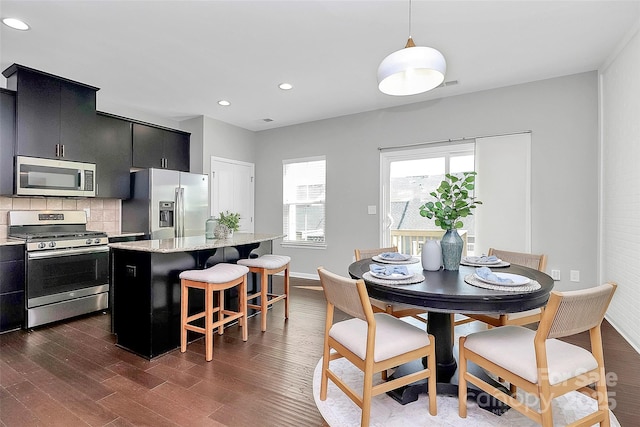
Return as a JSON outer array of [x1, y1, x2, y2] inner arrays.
[[2, 64, 98, 163]]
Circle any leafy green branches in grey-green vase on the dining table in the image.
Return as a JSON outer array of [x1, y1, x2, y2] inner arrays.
[[420, 172, 482, 270]]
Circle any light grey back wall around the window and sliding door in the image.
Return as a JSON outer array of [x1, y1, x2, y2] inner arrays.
[[255, 72, 598, 289]]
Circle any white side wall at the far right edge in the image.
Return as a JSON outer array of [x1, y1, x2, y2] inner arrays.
[[600, 22, 640, 351]]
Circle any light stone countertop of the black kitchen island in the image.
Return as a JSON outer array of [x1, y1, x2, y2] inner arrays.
[[109, 232, 284, 253]]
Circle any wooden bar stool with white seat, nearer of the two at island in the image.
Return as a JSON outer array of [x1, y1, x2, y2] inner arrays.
[[179, 263, 249, 362]]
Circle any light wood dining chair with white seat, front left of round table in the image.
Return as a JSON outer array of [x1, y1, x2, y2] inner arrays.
[[318, 267, 437, 426]]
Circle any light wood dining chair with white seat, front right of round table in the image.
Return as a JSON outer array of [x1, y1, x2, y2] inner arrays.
[[458, 283, 616, 427]]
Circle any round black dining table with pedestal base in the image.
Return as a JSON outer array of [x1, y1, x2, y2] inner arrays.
[[349, 258, 553, 413]]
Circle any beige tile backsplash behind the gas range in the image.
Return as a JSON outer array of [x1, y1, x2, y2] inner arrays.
[[0, 197, 122, 239]]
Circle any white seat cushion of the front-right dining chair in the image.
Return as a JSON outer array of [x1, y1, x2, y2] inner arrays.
[[464, 326, 598, 385]]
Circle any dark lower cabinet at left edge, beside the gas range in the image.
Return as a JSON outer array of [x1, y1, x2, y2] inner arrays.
[[0, 244, 25, 332]]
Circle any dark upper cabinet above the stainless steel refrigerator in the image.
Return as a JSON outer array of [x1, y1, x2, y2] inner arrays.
[[133, 123, 190, 172]]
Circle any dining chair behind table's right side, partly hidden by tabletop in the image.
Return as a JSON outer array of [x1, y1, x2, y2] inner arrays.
[[454, 248, 547, 327]]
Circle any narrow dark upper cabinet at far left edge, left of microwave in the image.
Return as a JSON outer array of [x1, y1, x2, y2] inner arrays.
[[0, 88, 16, 195]]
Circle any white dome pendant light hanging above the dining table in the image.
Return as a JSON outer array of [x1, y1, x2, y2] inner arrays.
[[378, 0, 447, 96]]
